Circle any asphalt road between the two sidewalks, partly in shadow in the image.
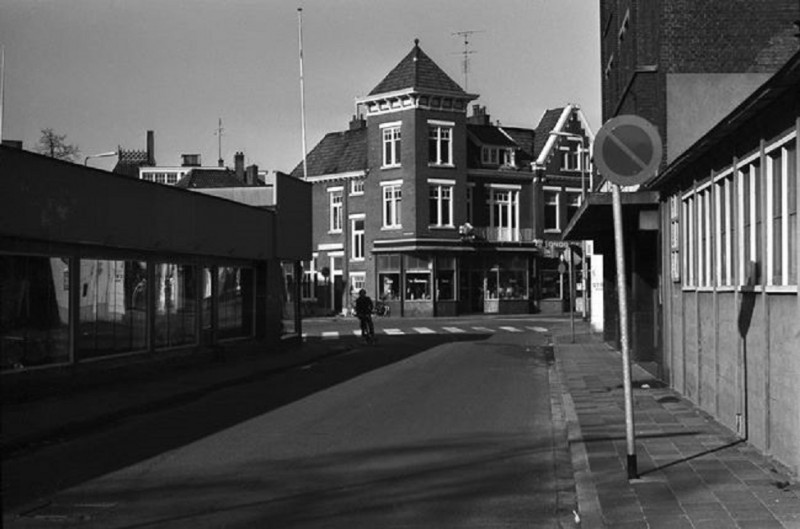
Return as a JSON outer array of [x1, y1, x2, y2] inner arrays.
[[4, 320, 568, 528]]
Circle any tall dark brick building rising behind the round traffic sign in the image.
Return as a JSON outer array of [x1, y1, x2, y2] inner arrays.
[[600, 0, 800, 163]]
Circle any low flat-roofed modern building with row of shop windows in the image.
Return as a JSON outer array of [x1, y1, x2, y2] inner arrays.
[[0, 146, 311, 373]]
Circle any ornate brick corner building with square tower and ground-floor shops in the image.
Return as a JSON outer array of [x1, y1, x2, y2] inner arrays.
[[293, 42, 591, 316]]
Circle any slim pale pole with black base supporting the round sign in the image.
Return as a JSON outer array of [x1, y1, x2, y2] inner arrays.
[[611, 184, 639, 479]]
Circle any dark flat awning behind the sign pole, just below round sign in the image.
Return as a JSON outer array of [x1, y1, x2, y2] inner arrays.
[[561, 191, 658, 241]]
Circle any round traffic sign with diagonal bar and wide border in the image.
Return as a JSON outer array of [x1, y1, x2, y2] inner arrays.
[[593, 115, 663, 186]]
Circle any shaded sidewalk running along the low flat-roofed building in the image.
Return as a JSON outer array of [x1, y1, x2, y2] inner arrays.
[[0, 342, 343, 458]]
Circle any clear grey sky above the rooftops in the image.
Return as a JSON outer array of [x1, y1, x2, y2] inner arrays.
[[0, 0, 601, 172]]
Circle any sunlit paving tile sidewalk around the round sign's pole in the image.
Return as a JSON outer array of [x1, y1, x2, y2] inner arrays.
[[554, 334, 800, 529]]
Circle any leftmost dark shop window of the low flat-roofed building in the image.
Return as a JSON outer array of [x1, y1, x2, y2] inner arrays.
[[0, 255, 70, 371]]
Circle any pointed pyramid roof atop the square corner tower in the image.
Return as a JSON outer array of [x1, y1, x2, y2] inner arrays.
[[369, 39, 467, 96]]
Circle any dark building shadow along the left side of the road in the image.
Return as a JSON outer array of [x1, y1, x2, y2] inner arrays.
[[2, 333, 506, 512]]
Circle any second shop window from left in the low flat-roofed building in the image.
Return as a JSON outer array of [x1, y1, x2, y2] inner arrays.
[[78, 259, 148, 359]]
